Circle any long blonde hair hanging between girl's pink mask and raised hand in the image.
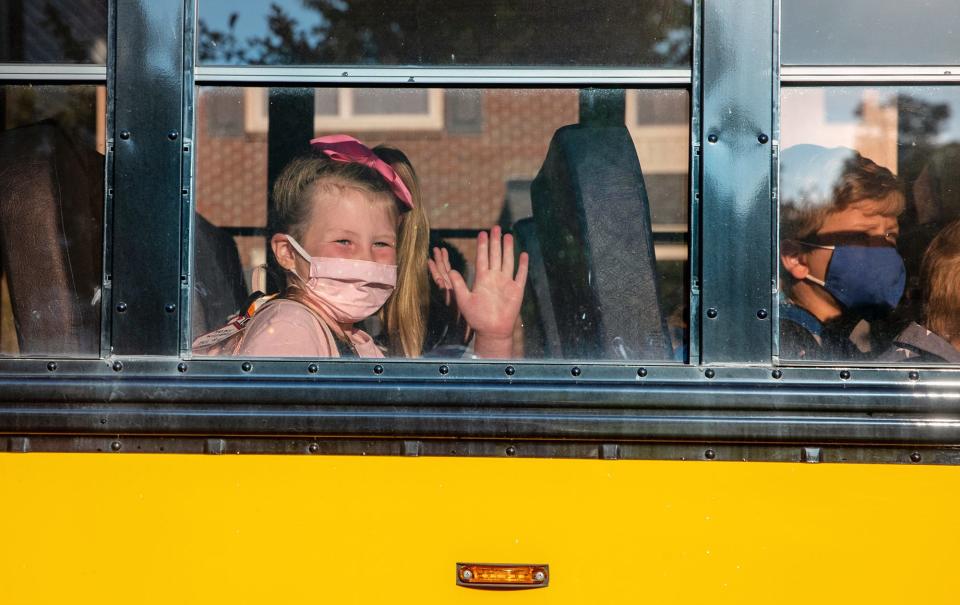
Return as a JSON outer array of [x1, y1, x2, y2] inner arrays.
[[373, 145, 430, 357]]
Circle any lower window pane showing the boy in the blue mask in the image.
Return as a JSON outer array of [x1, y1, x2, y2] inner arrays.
[[780, 86, 960, 364]]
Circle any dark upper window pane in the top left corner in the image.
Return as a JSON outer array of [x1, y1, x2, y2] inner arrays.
[[0, 0, 107, 64]]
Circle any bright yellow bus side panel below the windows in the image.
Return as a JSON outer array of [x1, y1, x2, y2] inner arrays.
[[0, 453, 960, 604]]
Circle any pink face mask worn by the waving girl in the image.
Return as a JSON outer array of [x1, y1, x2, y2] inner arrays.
[[287, 235, 397, 323]]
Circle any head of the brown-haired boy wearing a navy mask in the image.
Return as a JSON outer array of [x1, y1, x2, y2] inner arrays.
[[780, 145, 905, 321]]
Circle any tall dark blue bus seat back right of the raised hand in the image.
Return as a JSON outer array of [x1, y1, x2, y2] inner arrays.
[[531, 125, 673, 361]]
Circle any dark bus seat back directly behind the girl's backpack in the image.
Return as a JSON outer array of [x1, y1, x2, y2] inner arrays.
[[190, 213, 247, 338]]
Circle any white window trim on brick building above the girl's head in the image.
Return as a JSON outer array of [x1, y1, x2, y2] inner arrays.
[[243, 88, 444, 133]]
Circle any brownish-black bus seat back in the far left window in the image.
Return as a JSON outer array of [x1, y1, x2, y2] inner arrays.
[[0, 122, 103, 356]]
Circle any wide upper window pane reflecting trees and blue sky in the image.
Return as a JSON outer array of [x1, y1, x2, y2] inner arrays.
[[199, 0, 691, 67]]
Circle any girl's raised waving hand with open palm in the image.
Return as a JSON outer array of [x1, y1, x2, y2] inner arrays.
[[446, 227, 529, 358]]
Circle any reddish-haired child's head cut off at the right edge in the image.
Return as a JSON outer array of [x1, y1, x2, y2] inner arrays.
[[921, 220, 960, 349]]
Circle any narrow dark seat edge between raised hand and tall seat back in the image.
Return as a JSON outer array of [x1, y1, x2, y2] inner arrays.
[[513, 217, 563, 359]]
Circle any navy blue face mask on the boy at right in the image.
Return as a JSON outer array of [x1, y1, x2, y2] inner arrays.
[[806, 243, 907, 319]]
